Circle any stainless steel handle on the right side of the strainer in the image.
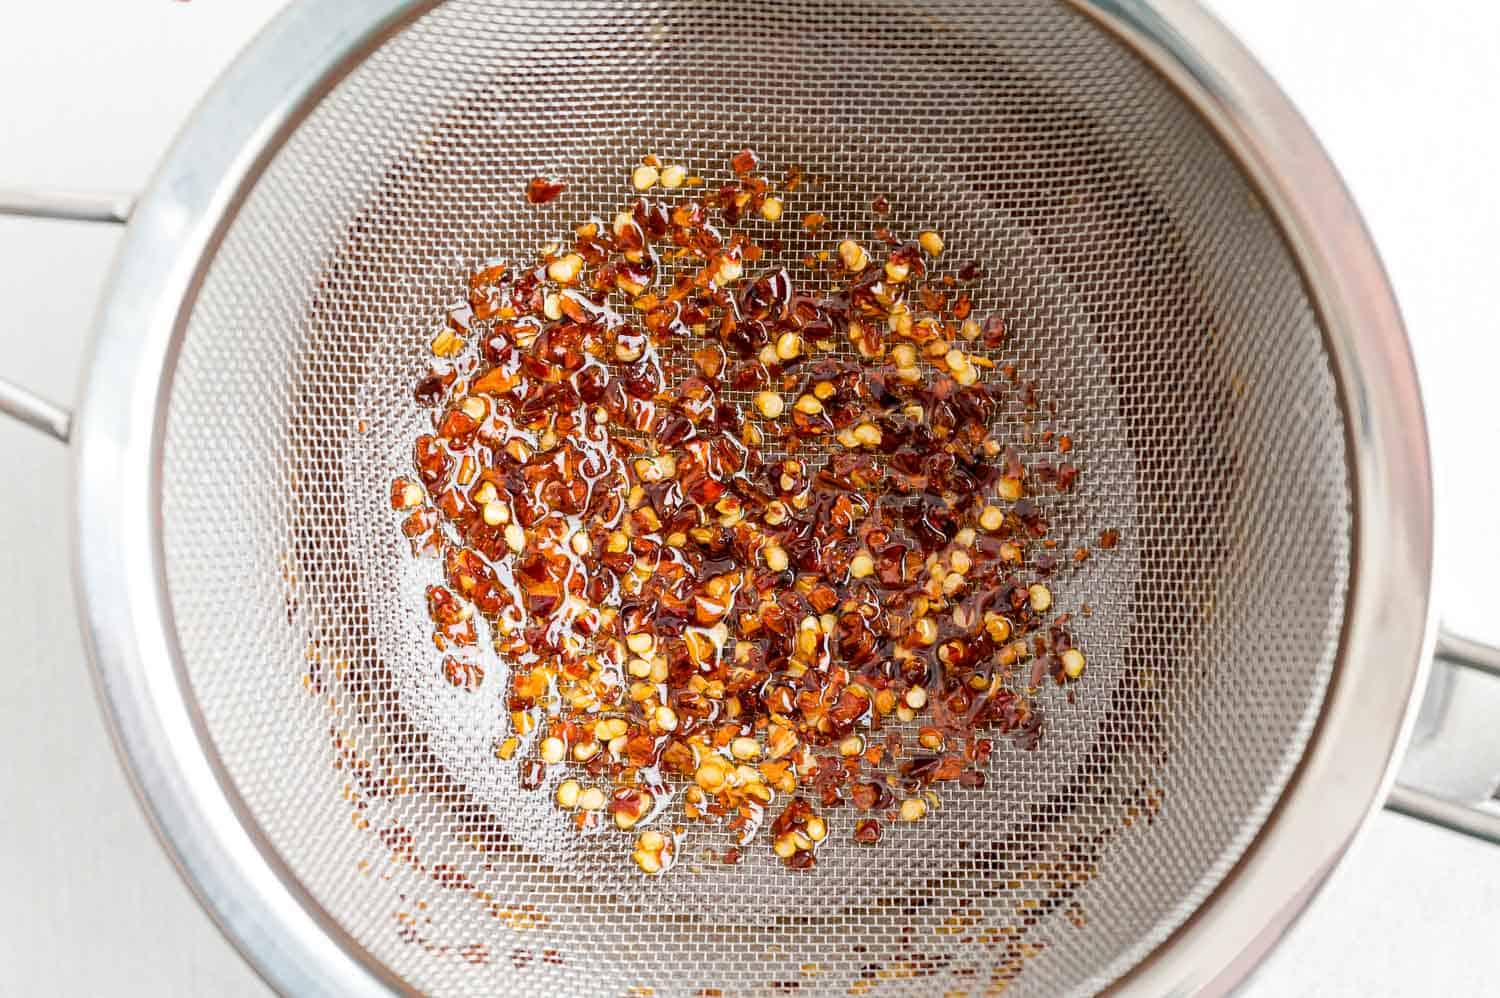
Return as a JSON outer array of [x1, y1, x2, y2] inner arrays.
[[1386, 630, 1500, 843]]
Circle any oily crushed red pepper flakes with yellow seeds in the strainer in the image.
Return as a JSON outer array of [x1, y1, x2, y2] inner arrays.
[[392, 150, 1118, 873]]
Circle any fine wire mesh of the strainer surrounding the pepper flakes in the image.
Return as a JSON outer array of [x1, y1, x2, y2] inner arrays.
[[162, 0, 1352, 995]]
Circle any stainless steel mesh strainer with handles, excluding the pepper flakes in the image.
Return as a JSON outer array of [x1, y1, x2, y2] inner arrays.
[[0, 0, 1500, 995]]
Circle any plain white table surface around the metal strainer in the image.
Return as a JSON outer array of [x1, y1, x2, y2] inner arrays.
[[0, 0, 1500, 998]]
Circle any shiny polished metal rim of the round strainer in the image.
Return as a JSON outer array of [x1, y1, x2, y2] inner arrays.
[[72, 0, 1433, 995]]
